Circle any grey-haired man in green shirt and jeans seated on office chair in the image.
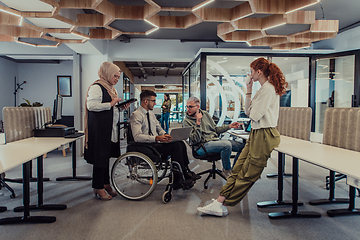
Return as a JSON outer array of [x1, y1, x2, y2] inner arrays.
[[183, 97, 245, 178]]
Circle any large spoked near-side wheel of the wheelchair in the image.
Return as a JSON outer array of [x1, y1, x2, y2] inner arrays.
[[111, 152, 158, 200]]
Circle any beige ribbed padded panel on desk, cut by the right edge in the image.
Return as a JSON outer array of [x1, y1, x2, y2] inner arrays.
[[323, 107, 360, 152]]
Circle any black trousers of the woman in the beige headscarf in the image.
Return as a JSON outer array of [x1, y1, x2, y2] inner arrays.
[[92, 142, 120, 189]]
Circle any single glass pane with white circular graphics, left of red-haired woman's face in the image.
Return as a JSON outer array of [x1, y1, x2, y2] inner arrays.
[[206, 56, 260, 126]]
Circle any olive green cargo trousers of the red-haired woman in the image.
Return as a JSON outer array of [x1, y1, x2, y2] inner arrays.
[[220, 128, 280, 206]]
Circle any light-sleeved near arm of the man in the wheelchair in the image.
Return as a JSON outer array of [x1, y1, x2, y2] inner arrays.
[[130, 112, 155, 143]]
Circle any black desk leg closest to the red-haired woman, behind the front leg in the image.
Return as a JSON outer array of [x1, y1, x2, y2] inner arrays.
[[257, 152, 303, 208]]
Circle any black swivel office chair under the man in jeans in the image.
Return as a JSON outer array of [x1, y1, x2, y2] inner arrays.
[[190, 143, 226, 189]]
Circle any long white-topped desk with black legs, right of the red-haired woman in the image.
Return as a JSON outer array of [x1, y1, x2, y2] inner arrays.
[[228, 133, 360, 218]]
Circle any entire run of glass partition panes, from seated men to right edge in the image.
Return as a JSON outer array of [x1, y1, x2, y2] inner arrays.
[[183, 51, 360, 133]]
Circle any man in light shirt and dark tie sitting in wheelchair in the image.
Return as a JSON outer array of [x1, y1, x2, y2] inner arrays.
[[130, 90, 200, 190]]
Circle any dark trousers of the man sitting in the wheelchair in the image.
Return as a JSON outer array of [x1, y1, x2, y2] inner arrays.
[[152, 141, 189, 173]]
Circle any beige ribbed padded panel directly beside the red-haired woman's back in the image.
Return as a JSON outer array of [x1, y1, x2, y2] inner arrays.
[[277, 107, 312, 141]]
